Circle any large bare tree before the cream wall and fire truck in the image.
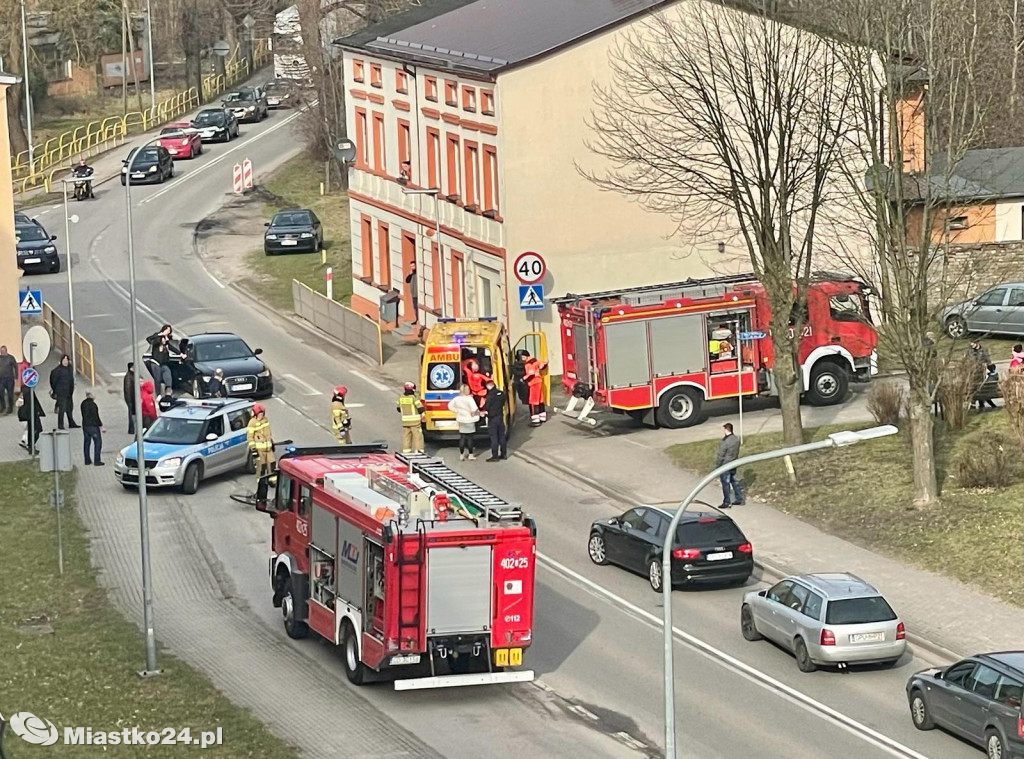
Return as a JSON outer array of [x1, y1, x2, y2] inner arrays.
[[584, 2, 847, 444]]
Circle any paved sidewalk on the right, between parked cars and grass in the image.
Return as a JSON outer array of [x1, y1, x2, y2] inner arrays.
[[515, 407, 1024, 657]]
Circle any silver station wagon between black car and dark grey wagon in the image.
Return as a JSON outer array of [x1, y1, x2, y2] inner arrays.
[[739, 573, 906, 672]]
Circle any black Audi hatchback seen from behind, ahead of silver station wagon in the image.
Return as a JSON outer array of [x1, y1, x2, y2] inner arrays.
[[587, 506, 754, 592]]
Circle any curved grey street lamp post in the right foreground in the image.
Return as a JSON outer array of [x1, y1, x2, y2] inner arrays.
[[662, 424, 899, 759]]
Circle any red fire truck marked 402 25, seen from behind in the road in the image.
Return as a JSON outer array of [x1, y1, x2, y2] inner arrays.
[[257, 442, 537, 690]]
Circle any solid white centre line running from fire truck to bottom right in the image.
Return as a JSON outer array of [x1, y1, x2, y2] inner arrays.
[[537, 552, 928, 759]]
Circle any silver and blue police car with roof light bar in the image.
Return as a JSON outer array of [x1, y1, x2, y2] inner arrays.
[[114, 398, 253, 495]]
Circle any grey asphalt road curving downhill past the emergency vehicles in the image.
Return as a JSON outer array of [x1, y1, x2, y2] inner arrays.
[[16, 104, 980, 759]]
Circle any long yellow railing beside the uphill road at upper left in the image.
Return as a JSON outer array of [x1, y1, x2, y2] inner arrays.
[[10, 40, 270, 195]]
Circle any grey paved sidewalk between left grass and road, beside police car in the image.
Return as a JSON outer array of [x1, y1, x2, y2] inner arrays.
[[0, 387, 440, 759]]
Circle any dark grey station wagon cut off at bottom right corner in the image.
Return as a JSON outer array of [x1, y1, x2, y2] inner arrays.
[[906, 651, 1024, 759]]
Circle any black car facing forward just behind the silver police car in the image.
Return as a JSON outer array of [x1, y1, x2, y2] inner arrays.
[[144, 332, 273, 397]]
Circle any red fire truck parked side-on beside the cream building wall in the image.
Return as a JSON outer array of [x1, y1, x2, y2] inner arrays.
[[555, 275, 878, 427]]
